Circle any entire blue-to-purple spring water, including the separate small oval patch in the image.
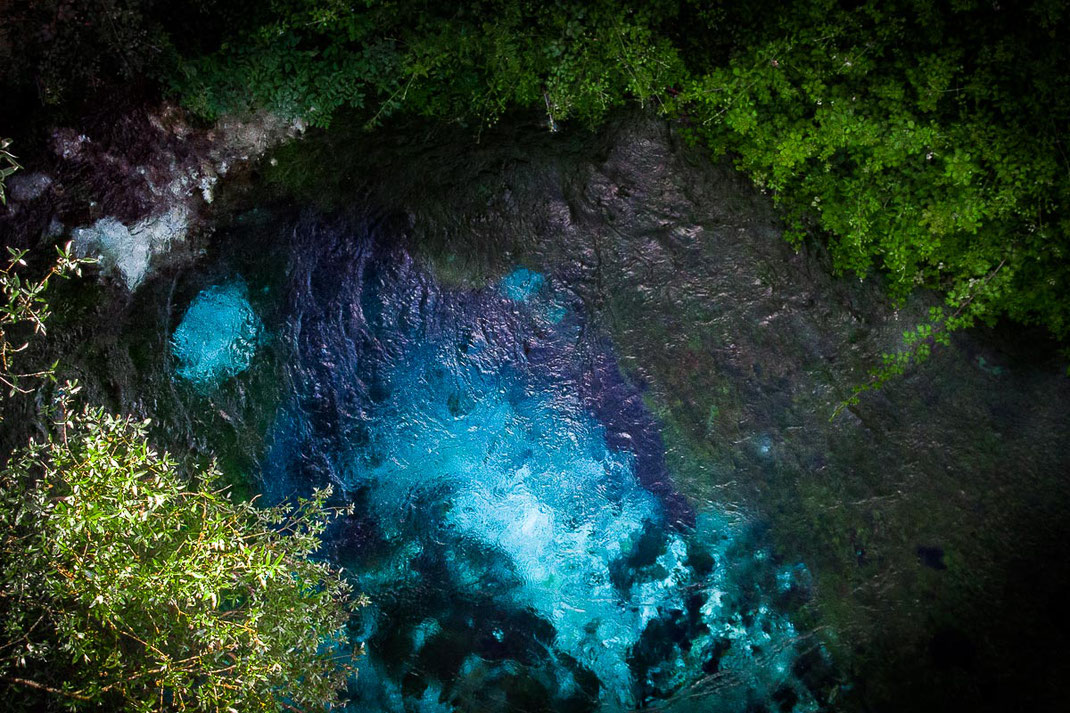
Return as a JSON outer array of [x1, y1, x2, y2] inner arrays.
[[175, 219, 827, 712]]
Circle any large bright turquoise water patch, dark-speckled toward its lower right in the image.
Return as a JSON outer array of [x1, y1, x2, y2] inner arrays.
[[339, 329, 817, 712]]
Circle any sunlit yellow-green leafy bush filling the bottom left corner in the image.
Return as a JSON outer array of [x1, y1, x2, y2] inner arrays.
[[0, 396, 352, 711]]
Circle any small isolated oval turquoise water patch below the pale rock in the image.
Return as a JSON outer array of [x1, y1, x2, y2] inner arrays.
[[171, 279, 262, 390]]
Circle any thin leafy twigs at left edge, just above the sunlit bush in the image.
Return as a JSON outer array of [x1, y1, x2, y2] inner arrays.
[[0, 243, 93, 397]]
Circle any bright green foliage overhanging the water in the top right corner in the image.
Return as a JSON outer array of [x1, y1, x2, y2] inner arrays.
[[676, 0, 1070, 382]]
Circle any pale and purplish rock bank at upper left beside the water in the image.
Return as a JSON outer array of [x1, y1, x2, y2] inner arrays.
[[0, 105, 304, 291]]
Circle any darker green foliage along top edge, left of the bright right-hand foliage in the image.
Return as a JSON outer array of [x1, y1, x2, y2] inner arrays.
[[175, 0, 683, 125]]
